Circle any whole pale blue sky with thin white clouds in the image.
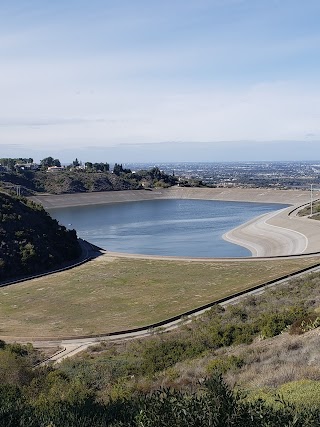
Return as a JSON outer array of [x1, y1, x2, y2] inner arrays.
[[0, 0, 320, 163]]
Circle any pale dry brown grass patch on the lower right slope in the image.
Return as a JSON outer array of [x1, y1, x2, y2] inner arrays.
[[139, 329, 320, 391]]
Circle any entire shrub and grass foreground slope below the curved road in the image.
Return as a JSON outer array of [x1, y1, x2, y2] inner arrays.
[[0, 274, 320, 427]]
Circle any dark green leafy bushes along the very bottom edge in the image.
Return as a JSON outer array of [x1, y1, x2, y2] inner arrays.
[[0, 374, 320, 427]]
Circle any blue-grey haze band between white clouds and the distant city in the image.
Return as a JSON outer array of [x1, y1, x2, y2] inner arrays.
[[0, 141, 320, 164]]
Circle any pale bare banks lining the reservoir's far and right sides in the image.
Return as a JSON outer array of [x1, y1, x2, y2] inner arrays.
[[32, 187, 320, 257]]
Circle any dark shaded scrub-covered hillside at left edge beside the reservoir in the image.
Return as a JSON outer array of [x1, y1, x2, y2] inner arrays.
[[0, 193, 80, 281]]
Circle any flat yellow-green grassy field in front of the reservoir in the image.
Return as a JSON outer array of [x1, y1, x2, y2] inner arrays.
[[0, 255, 319, 339]]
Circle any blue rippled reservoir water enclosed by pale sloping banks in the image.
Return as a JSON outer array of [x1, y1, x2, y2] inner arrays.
[[50, 200, 287, 257]]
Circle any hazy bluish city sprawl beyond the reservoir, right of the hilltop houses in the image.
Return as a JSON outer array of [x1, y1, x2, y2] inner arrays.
[[124, 160, 320, 189]]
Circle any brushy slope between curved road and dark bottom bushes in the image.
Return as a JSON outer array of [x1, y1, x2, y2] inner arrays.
[[61, 273, 320, 400]]
